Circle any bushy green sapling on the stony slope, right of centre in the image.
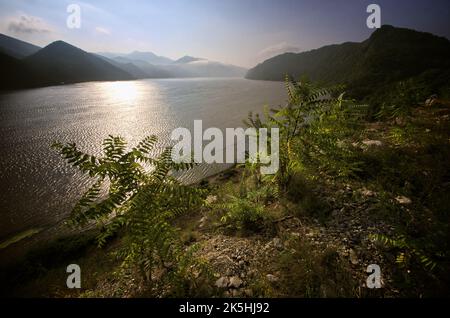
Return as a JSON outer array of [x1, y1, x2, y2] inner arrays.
[[246, 77, 367, 189]]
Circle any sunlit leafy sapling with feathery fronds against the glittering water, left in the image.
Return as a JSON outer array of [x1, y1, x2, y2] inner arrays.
[[53, 136, 203, 294]]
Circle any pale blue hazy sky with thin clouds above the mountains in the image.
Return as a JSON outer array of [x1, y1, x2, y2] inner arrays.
[[0, 0, 450, 67]]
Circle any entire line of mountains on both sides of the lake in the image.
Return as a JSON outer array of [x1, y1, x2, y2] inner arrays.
[[0, 25, 450, 95]]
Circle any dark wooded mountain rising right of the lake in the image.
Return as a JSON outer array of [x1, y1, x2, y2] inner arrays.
[[246, 25, 450, 97]]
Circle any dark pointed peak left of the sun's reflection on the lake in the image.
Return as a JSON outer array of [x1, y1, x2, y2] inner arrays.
[[23, 41, 133, 85]]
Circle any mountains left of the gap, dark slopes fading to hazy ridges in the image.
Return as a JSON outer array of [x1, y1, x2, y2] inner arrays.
[[0, 34, 247, 89]]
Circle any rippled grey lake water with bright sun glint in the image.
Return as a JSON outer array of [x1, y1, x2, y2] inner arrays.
[[0, 78, 286, 240]]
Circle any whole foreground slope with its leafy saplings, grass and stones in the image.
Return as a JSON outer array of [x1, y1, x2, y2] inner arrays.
[[0, 74, 450, 297]]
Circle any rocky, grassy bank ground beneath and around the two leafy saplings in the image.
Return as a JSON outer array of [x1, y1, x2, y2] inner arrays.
[[2, 100, 450, 297]]
